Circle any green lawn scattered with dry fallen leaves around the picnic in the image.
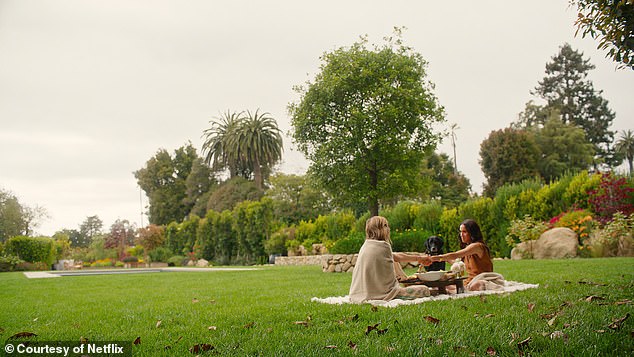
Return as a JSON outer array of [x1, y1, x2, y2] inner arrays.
[[0, 258, 634, 356]]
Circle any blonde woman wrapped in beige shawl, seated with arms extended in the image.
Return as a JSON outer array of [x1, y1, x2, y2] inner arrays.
[[349, 216, 431, 303]]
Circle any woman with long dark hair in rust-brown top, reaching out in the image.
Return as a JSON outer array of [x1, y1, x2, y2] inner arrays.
[[430, 219, 504, 291]]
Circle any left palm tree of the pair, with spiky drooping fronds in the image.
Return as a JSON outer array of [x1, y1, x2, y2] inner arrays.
[[203, 110, 243, 178]]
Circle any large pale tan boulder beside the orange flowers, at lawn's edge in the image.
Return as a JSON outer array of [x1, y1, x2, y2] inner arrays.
[[511, 227, 579, 259]]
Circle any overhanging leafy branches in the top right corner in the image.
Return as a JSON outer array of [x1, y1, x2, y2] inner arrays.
[[570, 0, 634, 69]]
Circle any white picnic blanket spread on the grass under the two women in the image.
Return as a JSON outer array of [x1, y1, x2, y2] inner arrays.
[[310, 280, 539, 307]]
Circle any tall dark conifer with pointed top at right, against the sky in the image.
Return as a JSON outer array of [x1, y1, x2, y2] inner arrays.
[[520, 44, 618, 167]]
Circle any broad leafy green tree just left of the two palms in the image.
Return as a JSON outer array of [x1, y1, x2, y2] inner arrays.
[[134, 143, 198, 225]]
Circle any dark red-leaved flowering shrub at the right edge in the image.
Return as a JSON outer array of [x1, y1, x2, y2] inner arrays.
[[588, 172, 634, 224]]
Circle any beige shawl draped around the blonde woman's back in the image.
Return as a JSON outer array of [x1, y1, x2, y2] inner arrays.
[[350, 239, 400, 302]]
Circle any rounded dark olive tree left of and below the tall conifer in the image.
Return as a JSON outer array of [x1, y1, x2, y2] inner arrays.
[[480, 128, 540, 197]]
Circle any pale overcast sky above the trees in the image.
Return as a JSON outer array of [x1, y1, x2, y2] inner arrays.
[[0, 0, 634, 235]]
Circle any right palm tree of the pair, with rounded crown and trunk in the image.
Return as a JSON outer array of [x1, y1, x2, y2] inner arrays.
[[231, 109, 283, 190]]
